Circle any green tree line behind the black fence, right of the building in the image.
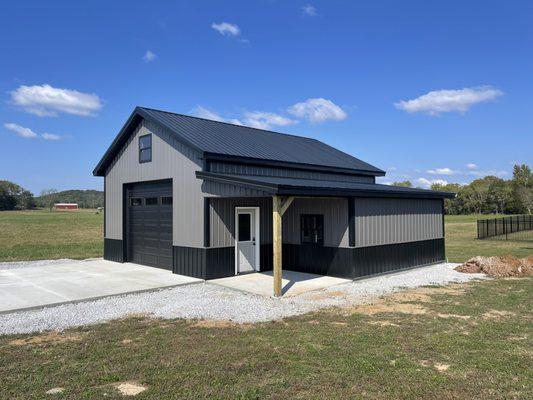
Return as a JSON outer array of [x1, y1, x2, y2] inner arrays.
[[393, 164, 533, 214]]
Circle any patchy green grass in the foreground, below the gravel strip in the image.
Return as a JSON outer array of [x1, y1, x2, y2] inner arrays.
[[0, 278, 533, 400]]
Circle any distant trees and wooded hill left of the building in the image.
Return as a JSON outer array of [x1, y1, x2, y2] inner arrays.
[[0, 181, 104, 211]]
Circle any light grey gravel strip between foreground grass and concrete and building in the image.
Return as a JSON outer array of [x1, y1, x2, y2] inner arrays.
[[0, 264, 484, 335]]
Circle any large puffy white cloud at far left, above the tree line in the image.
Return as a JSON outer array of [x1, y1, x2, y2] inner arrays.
[[11, 85, 102, 117]]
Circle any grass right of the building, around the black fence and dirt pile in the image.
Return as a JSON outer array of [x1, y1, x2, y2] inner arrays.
[[445, 215, 533, 262]]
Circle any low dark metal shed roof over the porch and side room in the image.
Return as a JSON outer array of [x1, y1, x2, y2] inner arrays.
[[196, 171, 455, 199]]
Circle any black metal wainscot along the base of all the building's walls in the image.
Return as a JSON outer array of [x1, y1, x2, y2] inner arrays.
[[172, 239, 445, 279]]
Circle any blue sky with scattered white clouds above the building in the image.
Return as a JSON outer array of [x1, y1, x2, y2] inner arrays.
[[0, 0, 533, 193]]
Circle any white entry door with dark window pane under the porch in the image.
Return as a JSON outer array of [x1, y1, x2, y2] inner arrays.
[[235, 207, 259, 274]]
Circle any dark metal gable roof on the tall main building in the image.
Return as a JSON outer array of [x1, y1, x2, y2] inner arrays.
[[93, 107, 385, 176]]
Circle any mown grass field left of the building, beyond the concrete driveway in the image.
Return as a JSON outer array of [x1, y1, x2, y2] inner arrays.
[[0, 210, 103, 261]]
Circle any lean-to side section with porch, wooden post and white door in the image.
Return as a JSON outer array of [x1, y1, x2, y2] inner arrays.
[[191, 172, 445, 296]]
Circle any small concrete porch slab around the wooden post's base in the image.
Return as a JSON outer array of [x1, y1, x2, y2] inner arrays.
[[208, 270, 352, 297]]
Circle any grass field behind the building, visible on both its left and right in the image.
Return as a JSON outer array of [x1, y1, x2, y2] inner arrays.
[[0, 209, 533, 262]]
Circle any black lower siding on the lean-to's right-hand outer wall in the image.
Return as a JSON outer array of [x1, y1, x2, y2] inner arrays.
[[353, 239, 445, 278]]
